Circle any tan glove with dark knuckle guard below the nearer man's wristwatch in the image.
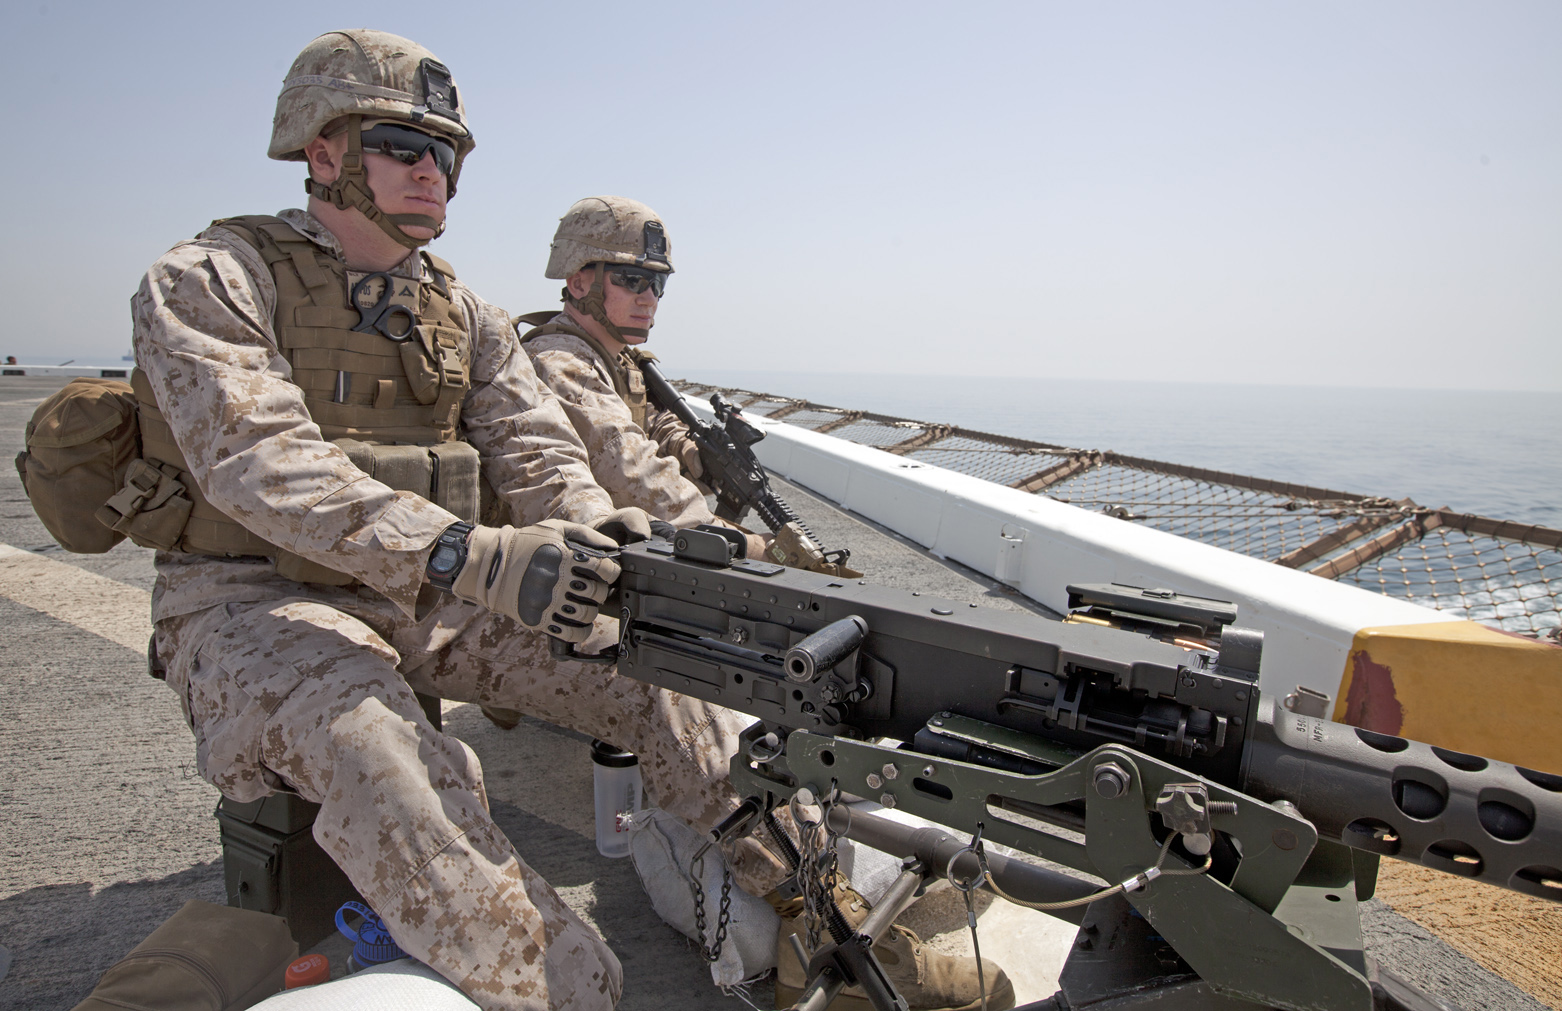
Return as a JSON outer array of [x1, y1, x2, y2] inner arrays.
[[450, 519, 619, 642]]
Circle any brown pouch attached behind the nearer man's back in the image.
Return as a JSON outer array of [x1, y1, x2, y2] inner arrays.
[[16, 378, 191, 555]]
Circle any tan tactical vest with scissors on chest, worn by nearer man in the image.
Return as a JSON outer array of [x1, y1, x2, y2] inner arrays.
[[131, 214, 478, 586]]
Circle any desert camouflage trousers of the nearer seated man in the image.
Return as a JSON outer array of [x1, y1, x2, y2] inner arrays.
[[158, 591, 786, 1011]]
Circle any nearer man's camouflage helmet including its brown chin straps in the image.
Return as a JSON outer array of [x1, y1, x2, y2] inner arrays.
[[267, 28, 476, 248]]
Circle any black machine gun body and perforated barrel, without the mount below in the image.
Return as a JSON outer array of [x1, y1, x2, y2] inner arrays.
[[619, 531, 1562, 900]]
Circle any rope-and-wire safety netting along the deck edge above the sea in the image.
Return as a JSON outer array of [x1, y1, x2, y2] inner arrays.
[[679, 383, 1562, 639]]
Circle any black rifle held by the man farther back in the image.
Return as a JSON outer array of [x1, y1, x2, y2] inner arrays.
[[639, 358, 851, 567]]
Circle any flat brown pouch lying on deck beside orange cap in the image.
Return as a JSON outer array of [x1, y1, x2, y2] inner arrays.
[[73, 898, 298, 1011]]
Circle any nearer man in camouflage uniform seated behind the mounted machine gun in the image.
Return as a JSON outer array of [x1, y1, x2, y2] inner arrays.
[[133, 31, 783, 1009]]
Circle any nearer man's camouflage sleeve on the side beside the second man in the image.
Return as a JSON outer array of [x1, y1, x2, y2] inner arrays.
[[461, 291, 614, 527]]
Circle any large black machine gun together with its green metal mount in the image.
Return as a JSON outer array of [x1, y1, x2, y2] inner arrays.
[[587, 531, 1562, 1011]]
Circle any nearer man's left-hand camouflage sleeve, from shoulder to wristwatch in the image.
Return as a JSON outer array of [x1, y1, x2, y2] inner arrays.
[[131, 228, 456, 614]]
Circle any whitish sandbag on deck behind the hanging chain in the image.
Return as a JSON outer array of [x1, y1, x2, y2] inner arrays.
[[615, 808, 781, 986]]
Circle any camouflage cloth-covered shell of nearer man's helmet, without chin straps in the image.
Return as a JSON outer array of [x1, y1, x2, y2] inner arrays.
[[267, 28, 475, 168]]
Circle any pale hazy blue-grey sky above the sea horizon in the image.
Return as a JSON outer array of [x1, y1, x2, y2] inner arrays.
[[0, 0, 1562, 389]]
